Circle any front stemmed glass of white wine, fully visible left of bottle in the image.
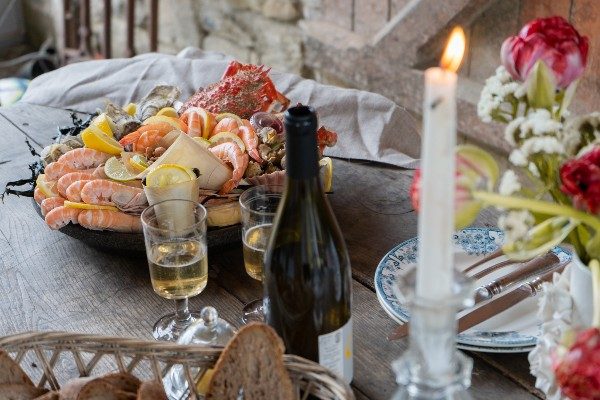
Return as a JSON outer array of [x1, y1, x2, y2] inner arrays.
[[142, 200, 208, 341]]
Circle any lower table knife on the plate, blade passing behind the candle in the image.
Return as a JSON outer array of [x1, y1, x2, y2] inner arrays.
[[388, 262, 568, 340]]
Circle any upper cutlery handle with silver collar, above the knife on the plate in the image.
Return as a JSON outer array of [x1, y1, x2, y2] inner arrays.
[[475, 252, 560, 304]]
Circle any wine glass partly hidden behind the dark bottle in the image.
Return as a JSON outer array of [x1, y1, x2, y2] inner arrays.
[[240, 185, 283, 323]]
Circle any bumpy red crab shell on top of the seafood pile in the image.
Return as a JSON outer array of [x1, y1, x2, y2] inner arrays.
[[180, 61, 290, 119]]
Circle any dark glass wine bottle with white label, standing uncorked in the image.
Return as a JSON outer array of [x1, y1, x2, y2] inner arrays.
[[264, 106, 353, 382]]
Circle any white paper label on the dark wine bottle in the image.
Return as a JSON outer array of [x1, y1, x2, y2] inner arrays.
[[319, 318, 354, 383]]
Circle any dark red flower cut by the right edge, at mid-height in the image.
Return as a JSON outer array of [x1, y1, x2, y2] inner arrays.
[[560, 146, 600, 214]]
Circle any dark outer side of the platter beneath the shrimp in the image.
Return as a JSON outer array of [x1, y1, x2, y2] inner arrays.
[[32, 199, 242, 253]]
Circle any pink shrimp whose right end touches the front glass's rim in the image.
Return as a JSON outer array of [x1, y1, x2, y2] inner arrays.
[[80, 179, 147, 210]]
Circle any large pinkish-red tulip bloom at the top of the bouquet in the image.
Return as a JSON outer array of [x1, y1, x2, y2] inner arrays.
[[500, 17, 588, 89]]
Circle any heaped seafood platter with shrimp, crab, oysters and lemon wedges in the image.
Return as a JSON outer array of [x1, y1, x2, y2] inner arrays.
[[34, 61, 337, 250]]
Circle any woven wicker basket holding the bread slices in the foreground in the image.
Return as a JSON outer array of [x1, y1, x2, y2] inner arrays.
[[0, 332, 354, 400]]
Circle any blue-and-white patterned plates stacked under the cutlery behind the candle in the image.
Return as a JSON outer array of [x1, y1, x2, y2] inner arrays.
[[375, 228, 571, 352]]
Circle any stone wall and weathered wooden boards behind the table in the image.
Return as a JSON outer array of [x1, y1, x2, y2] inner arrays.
[[16, 0, 600, 154]]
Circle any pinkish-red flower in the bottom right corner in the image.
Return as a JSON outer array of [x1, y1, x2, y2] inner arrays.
[[553, 328, 600, 400]]
